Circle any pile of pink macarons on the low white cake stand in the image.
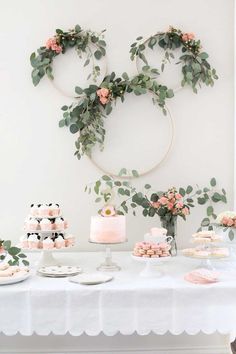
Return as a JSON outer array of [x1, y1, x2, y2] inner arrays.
[[133, 241, 171, 258]]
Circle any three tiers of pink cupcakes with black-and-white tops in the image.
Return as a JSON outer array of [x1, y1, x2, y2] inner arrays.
[[20, 203, 75, 250]]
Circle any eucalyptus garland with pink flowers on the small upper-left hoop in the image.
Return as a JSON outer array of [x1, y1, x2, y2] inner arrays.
[[30, 25, 106, 86]]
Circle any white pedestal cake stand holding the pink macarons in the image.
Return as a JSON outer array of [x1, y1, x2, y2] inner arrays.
[[132, 255, 172, 278]]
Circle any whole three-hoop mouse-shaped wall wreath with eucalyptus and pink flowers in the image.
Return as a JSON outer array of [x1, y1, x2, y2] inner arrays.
[[30, 25, 218, 178]]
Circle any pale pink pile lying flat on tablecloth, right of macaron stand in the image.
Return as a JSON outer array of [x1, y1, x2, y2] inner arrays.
[[184, 268, 219, 284]]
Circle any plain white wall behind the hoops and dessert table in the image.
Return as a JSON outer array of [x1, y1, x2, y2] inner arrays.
[[0, 0, 233, 250]]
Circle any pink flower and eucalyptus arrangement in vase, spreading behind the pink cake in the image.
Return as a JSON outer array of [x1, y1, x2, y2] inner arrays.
[[85, 168, 227, 255]]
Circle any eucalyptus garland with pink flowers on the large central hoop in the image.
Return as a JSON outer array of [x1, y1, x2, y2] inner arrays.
[[59, 72, 174, 159]]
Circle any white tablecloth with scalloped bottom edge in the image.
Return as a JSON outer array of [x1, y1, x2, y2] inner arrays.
[[0, 252, 236, 336]]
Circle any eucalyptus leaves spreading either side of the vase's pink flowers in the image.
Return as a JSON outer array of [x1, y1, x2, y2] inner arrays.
[[85, 172, 227, 231]]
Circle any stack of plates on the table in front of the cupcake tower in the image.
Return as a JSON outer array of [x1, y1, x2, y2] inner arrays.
[[38, 266, 82, 278]]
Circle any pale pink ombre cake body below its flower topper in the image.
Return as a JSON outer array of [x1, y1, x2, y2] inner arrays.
[[90, 215, 126, 244]]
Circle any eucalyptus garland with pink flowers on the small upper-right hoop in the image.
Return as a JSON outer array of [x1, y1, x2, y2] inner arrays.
[[130, 27, 218, 93]]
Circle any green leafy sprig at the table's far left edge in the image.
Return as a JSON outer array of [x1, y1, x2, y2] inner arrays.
[[0, 240, 29, 266]]
